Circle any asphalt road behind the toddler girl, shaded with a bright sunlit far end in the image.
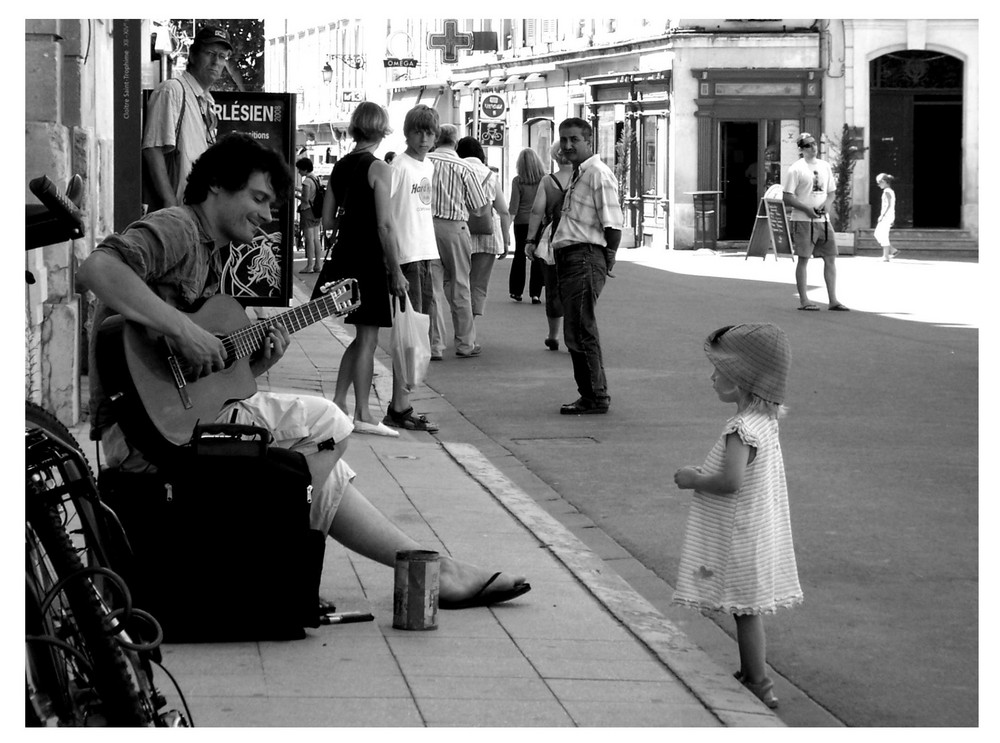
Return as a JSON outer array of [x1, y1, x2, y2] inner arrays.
[[296, 248, 979, 726]]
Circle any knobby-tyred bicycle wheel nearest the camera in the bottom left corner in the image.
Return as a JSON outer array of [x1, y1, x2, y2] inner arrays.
[[25, 497, 153, 726]]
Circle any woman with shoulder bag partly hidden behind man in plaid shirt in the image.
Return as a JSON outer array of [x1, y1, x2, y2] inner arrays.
[[524, 142, 573, 351]]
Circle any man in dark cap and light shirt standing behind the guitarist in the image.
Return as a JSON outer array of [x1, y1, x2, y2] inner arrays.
[[142, 26, 233, 211]]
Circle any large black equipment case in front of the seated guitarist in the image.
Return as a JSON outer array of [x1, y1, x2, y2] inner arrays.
[[99, 424, 326, 642]]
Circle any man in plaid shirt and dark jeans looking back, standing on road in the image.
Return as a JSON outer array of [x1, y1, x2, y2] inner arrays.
[[552, 118, 624, 415]]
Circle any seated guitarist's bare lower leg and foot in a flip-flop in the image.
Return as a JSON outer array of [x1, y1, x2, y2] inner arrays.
[[330, 485, 524, 601]]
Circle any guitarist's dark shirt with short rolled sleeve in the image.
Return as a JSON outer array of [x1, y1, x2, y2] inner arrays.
[[89, 206, 223, 432]]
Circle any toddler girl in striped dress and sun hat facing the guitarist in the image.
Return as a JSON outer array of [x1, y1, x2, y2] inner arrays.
[[674, 323, 802, 708]]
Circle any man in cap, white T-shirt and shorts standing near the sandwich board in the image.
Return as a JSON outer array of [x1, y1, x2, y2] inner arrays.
[[783, 132, 847, 312]]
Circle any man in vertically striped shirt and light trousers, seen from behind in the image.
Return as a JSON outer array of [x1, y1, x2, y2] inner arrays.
[[427, 124, 490, 359]]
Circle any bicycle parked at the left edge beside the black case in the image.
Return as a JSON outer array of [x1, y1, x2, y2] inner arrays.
[[25, 176, 193, 727]]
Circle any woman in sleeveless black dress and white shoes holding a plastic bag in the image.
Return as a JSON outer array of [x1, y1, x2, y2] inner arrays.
[[316, 101, 418, 436]]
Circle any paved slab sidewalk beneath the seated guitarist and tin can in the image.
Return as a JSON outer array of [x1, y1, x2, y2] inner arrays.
[[70, 276, 781, 727]]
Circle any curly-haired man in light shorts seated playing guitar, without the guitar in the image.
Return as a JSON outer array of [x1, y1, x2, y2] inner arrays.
[[77, 134, 530, 609]]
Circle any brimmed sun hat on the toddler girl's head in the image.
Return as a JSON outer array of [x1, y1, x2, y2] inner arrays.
[[705, 323, 792, 405]]
